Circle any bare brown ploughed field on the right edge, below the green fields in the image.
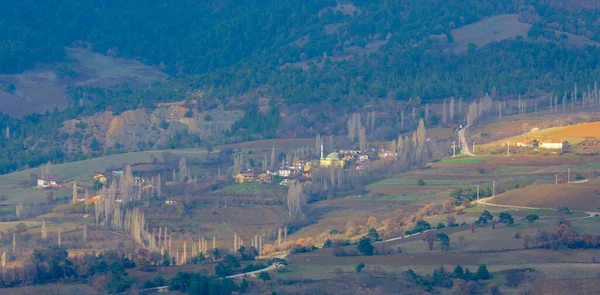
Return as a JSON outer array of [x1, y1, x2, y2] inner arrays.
[[490, 180, 600, 211]]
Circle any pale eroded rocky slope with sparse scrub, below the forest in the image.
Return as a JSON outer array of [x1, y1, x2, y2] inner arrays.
[[61, 104, 243, 152]]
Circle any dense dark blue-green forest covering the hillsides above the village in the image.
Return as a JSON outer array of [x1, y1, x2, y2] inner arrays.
[[0, 0, 600, 173]]
